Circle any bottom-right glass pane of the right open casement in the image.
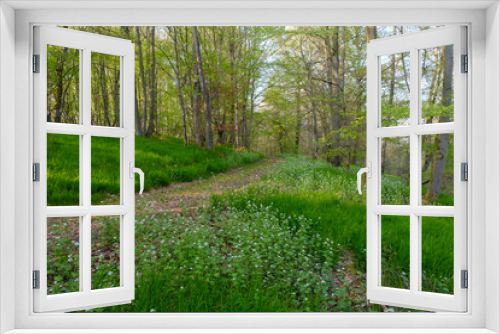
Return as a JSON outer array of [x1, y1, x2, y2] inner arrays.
[[422, 217, 454, 295]]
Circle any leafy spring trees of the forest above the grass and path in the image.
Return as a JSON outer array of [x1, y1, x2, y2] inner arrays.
[[47, 26, 453, 200]]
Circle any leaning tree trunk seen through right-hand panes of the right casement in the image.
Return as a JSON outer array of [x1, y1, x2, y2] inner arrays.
[[425, 45, 453, 201]]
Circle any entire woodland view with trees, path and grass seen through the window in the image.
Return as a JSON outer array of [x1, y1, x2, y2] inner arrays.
[[47, 26, 454, 312]]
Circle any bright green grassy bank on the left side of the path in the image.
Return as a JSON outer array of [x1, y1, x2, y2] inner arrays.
[[47, 134, 263, 206]]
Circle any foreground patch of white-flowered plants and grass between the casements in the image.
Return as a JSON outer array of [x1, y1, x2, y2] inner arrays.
[[93, 204, 345, 312]]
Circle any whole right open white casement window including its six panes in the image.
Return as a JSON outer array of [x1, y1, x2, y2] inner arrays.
[[367, 26, 467, 312]]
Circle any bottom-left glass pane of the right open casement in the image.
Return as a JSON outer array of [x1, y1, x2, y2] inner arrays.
[[381, 216, 410, 289]]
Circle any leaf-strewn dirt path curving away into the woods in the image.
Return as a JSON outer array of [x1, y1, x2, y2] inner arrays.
[[136, 158, 282, 214]]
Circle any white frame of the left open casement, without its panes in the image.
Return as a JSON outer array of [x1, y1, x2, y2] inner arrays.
[[33, 26, 135, 312]]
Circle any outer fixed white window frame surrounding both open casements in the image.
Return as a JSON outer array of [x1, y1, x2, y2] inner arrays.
[[0, 1, 500, 333]]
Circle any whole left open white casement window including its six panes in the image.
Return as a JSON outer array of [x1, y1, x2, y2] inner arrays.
[[33, 26, 135, 312]]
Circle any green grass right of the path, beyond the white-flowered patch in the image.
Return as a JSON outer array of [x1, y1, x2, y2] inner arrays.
[[214, 156, 453, 293]]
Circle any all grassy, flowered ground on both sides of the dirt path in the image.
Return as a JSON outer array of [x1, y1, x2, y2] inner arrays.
[[49, 139, 453, 312]]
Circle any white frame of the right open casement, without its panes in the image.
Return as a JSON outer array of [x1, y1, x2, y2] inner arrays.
[[366, 26, 468, 312]]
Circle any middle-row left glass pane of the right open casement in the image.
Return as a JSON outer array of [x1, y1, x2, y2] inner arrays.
[[380, 137, 410, 205]]
